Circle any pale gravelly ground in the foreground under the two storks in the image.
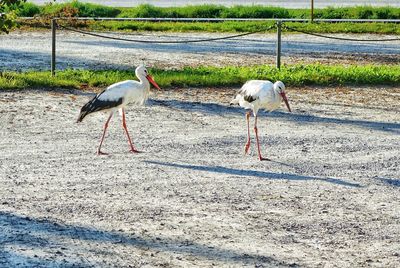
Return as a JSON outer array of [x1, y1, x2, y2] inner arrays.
[[0, 88, 400, 267]]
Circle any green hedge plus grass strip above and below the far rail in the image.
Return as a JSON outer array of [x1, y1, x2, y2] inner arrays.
[[12, 1, 400, 34]]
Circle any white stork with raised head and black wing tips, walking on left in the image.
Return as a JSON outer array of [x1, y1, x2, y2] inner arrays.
[[77, 65, 160, 155]]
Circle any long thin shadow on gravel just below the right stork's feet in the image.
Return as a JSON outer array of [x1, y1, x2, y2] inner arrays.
[[144, 160, 362, 187]]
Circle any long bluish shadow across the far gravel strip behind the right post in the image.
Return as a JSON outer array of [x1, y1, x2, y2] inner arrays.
[[63, 38, 399, 62]]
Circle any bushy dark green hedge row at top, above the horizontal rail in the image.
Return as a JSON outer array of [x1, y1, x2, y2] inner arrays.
[[13, 0, 400, 19]]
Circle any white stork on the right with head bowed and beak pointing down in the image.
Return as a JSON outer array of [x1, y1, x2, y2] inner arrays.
[[231, 80, 291, 161]]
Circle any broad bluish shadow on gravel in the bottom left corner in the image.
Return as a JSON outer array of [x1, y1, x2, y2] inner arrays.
[[0, 211, 289, 267]]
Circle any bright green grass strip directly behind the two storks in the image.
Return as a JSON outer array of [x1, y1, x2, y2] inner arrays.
[[0, 64, 400, 89]]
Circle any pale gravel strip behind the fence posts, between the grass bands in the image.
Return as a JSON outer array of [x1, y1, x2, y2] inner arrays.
[[0, 31, 400, 70]]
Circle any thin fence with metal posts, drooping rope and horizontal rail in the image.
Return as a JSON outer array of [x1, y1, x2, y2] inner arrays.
[[51, 18, 400, 75]]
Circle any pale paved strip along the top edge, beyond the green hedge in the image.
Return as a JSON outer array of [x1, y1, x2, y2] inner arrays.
[[29, 0, 400, 8]]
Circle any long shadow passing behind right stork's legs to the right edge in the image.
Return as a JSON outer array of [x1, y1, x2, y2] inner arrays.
[[148, 99, 400, 134]]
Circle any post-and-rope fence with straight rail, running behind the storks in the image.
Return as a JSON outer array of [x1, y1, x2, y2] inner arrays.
[[47, 18, 400, 76]]
